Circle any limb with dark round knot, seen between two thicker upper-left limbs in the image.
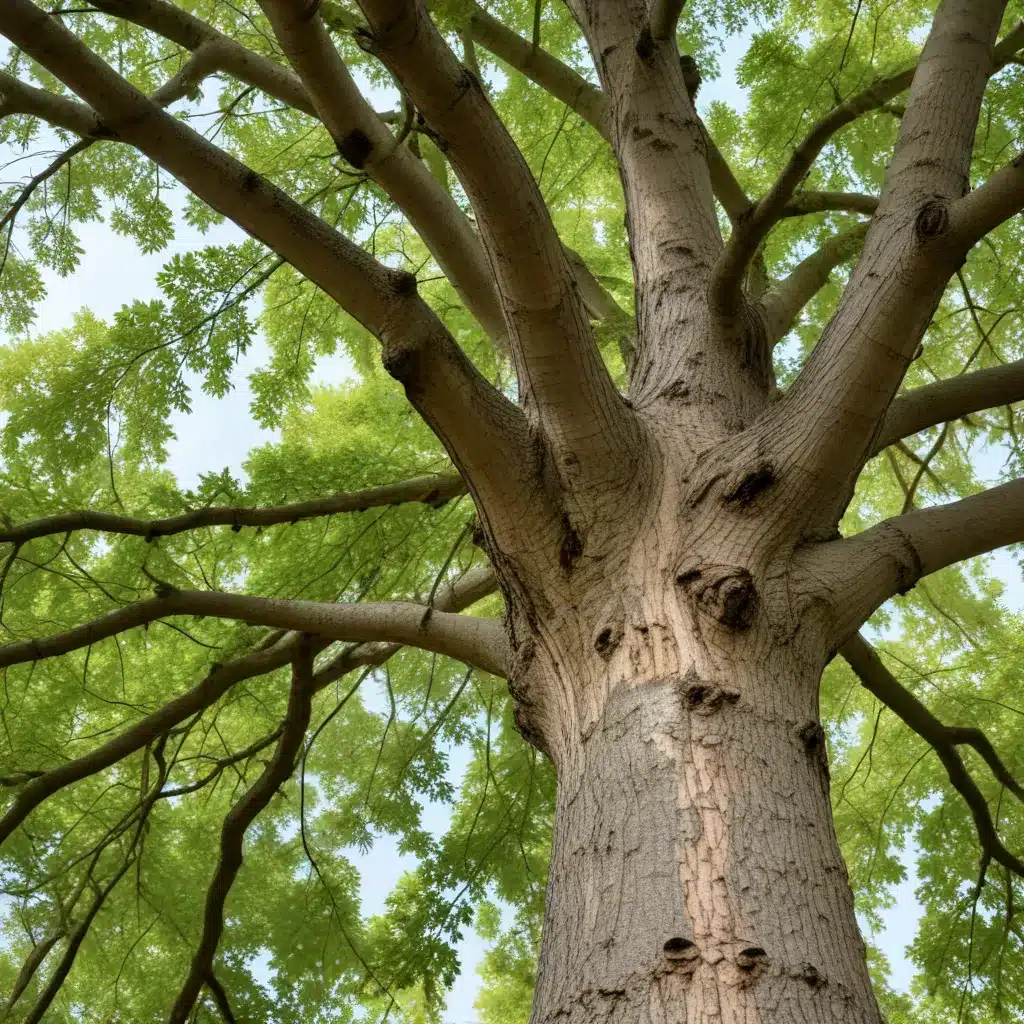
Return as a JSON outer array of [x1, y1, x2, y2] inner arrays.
[[262, 0, 505, 344]]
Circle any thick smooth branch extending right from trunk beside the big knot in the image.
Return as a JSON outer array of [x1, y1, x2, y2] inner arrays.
[[798, 479, 1024, 642]]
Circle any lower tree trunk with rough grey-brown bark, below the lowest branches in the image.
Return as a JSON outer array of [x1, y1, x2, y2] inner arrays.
[[532, 643, 880, 1024]]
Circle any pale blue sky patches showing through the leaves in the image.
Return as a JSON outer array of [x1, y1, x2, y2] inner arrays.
[[0, 16, 1024, 1024]]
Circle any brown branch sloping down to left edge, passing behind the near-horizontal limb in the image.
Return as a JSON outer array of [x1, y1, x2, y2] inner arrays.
[[0, 566, 497, 844]]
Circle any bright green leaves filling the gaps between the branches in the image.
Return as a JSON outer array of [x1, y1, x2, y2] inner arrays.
[[0, 0, 1024, 1024]]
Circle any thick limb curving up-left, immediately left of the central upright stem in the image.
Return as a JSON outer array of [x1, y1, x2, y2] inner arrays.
[[356, 0, 636, 478]]
